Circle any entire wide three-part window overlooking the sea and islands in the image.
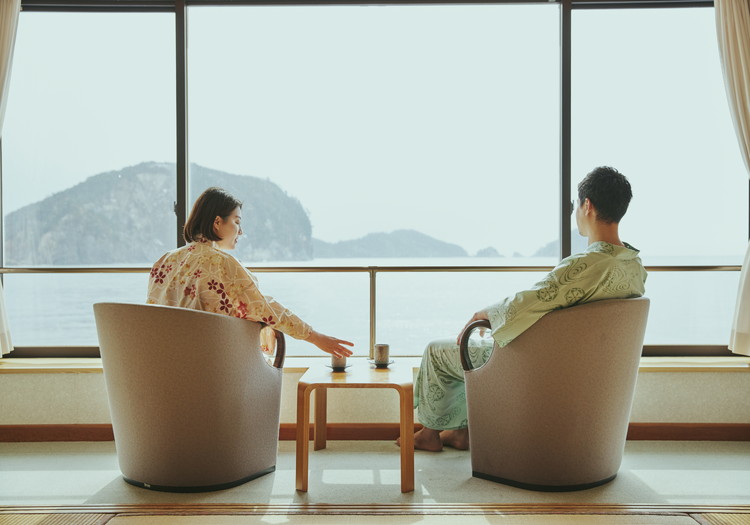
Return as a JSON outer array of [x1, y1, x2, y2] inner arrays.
[[0, 0, 750, 356]]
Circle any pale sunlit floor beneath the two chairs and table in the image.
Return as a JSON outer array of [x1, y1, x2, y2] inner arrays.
[[0, 441, 750, 525]]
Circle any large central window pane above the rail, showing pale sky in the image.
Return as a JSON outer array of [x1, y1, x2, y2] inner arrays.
[[188, 5, 559, 266]]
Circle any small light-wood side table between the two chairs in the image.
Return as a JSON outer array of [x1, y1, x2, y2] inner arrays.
[[297, 358, 414, 492]]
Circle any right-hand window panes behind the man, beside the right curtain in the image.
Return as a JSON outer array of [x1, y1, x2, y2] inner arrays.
[[572, 8, 748, 345]]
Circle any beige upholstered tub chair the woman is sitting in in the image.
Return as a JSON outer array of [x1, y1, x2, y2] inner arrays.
[[94, 303, 284, 492]]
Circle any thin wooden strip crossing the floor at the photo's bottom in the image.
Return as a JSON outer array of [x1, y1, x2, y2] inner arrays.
[[0, 503, 750, 516]]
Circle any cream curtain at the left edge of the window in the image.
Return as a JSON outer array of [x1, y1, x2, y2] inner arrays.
[[0, 0, 21, 356]]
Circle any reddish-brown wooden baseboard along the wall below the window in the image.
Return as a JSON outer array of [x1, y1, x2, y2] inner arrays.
[[0, 423, 750, 443]]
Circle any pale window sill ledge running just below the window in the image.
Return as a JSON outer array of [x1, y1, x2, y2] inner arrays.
[[0, 356, 750, 374]]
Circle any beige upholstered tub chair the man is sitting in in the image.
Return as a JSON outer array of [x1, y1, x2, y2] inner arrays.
[[461, 298, 649, 491]]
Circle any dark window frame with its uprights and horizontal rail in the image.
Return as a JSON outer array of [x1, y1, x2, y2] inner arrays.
[[0, 0, 750, 358]]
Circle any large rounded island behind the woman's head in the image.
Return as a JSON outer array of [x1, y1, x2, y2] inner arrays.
[[5, 162, 312, 266]]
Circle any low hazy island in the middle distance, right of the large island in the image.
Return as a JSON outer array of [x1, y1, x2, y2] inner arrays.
[[313, 230, 468, 259]]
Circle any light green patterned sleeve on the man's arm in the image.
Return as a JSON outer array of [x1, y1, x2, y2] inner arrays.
[[484, 255, 592, 347]]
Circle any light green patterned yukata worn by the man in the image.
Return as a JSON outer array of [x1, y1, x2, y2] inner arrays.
[[414, 241, 646, 430]]
